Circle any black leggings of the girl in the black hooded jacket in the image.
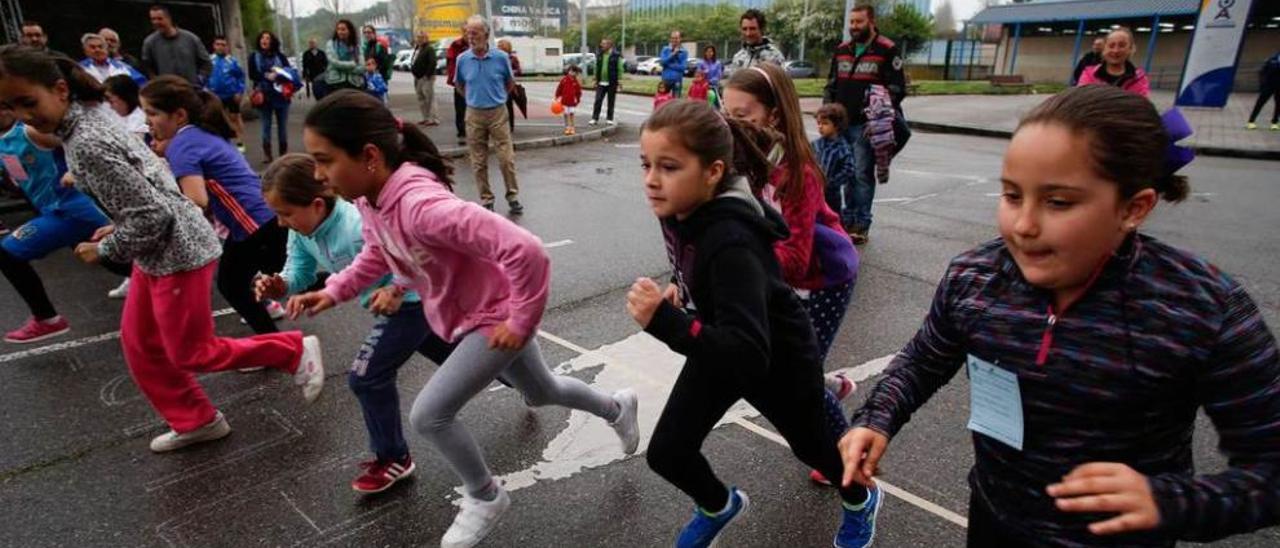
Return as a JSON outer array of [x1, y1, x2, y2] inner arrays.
[[648, 350, 867, 512]]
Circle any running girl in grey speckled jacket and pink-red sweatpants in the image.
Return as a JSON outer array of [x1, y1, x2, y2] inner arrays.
[[0, 46, 324, 452]]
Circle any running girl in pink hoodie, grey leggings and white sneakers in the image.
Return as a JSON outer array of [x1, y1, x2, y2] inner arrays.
[[288, 91, 640, 548]]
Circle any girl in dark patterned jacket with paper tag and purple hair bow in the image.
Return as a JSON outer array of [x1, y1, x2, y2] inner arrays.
[[841, 86, 1280, 547]]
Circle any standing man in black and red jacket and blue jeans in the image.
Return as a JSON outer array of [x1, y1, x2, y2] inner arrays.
[[824, 5, 906, 245]]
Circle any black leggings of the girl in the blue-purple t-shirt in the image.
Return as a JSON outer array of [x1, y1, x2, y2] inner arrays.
[[218, 220, 289, 334]]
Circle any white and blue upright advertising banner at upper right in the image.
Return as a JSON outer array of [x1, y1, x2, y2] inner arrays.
[[1176, 0, 1253, 108]]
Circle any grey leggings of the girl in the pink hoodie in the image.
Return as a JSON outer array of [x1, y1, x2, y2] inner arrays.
[[408, 332, 621, 497]]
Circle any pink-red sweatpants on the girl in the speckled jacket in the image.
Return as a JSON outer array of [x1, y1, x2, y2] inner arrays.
[[120, 261, 302, 433]]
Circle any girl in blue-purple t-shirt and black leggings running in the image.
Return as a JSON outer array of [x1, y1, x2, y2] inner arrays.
[[142, 76, 289, 334]]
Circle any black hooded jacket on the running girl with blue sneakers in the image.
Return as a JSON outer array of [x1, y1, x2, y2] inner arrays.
[[645, 179, 819, 389]]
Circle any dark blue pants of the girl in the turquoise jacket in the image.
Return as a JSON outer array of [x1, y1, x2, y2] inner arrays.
[[347, 302, 456, 460]]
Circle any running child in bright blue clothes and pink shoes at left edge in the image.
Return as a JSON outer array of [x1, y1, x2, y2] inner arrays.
[[0, 104, 129, 344]]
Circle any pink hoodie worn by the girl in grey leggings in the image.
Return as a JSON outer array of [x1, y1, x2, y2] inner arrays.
[[324, 163, 550, 342]]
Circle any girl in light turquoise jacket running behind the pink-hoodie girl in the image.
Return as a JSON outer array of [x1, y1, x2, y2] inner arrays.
[[256, 154, 453, 493]]
